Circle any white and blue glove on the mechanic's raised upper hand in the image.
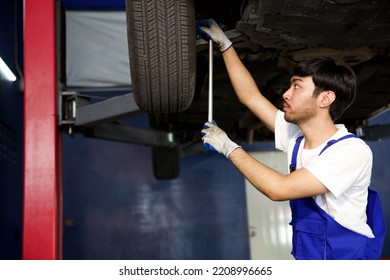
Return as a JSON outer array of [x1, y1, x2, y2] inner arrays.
[[196, 19, 232, 52]]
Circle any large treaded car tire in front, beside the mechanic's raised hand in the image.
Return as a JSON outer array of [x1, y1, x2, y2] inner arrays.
[[126, 0, 196, 113]]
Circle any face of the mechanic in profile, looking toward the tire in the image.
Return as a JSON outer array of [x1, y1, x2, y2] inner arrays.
[[283, 76, 317, 125]]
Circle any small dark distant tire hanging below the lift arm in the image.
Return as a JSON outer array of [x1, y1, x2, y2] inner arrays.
[[152, 146, 180, 180]]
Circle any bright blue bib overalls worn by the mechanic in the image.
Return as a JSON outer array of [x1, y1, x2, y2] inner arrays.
[[290, 134, 386, 260]]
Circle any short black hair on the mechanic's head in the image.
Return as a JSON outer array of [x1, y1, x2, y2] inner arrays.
[[293, 57, 356, 121]]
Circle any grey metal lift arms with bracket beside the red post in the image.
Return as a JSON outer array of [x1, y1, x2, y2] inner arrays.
[[58, 91, 178, 147]]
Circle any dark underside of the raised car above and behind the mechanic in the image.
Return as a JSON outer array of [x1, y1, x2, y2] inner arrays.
[[189, 0, 390, 142]]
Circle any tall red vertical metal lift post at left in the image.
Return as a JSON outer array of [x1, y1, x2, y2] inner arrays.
[[22, 0, 61, 260]]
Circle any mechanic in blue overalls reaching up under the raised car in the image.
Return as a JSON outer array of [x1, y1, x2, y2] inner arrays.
[[197, 19, 385, 259]]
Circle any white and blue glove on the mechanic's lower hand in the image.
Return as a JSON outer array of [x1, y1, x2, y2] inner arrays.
[[202, 122, 241, 158]]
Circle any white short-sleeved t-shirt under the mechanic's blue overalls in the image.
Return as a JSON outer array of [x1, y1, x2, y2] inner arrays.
[[275, 111, 374, 238]]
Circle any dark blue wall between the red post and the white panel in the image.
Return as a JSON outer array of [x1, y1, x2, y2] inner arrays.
[[63, 123, 249, 259]]
